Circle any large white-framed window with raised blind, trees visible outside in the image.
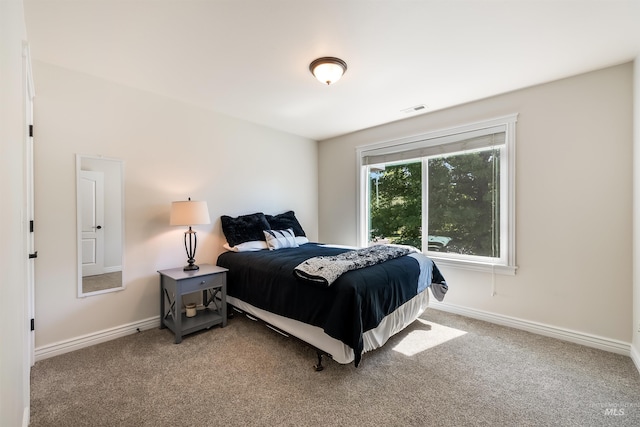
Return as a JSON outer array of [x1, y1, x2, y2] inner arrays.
[[357, 115, 516, 274]]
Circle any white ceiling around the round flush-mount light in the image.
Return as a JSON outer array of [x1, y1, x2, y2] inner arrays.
[[23, 0, 640, 140]]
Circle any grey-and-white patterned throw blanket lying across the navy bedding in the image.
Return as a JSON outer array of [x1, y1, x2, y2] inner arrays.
[[293, 245, 416, 286]]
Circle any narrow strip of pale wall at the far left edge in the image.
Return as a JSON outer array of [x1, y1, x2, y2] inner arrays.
[[0, 0, 29, 426]]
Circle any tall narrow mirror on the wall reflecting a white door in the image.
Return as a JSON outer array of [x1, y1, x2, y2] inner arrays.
[[76, 154, 124, 297]]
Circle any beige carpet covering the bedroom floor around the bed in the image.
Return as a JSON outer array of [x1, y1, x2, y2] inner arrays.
[[31, 309, 640, 427]]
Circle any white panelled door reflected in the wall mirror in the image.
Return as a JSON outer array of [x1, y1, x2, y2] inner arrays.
[[78, 171, 104, 277]]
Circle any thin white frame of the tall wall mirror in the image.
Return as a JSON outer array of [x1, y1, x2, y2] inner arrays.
[[76, 154, 125, 298]]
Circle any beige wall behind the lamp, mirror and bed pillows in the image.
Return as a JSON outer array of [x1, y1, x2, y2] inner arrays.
[[34, 61, 317, 353]]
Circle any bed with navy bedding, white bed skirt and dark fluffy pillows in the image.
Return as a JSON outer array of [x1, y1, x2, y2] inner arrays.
[[217, 211, 448, 370]]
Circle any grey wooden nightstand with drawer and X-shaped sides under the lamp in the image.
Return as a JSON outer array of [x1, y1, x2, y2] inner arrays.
[[158, 264, 228, 344]]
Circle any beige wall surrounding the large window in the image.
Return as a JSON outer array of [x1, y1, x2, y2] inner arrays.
[[319, 64, 633, 343]]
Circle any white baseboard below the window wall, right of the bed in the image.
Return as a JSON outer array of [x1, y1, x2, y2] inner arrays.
[[429, 300, 640, 358]]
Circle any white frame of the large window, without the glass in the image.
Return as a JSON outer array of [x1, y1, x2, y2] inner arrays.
[[356, 114, 518, 275]]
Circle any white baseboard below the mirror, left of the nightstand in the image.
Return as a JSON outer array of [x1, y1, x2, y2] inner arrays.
[[35, 316, 160, 362]]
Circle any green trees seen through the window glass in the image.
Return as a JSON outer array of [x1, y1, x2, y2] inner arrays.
[[369, 147, 500, 258]]
